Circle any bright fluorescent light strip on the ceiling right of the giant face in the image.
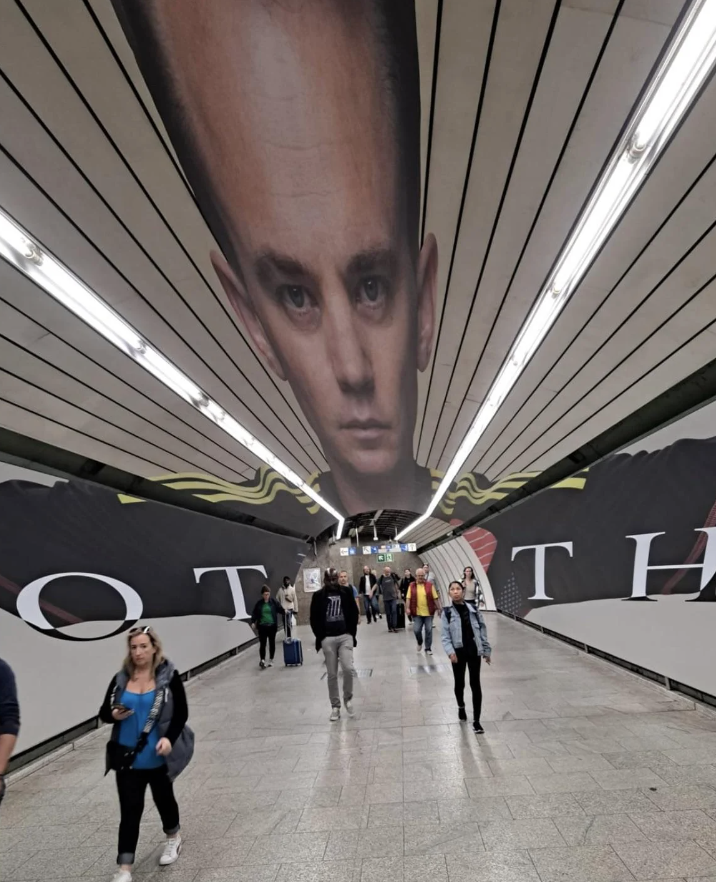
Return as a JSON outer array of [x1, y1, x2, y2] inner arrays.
[[396, 0, 716, 539]]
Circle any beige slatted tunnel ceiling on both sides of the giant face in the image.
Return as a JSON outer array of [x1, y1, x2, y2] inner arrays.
[[0, 0, 716, 540]]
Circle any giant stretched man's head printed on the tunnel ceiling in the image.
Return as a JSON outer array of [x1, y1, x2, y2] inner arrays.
[[115, 0, 437, 512]]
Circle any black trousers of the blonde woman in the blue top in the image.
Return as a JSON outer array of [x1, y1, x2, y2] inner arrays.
[[117, 766, 179, 864]]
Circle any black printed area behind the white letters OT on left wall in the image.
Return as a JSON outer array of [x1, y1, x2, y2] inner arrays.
[[0, 469, 305, 639]]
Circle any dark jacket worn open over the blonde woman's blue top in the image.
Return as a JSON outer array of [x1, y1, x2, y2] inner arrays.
[[99, 660, 194, 781]]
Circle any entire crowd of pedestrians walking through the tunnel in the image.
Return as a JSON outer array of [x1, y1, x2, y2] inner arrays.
[[0, 566, 492, 882]]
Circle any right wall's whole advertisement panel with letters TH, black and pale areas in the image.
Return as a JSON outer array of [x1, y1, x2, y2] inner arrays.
[[454, 405, 716, 695]]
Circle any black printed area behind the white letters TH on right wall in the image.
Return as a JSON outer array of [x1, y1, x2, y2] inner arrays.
[[466, 438, 716, 617]]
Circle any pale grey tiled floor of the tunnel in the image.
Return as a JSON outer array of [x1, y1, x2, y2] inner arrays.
[[0, 615, 716, 882]]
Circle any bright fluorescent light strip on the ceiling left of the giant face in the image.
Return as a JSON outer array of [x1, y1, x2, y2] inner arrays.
[[0, 209, 345, 536]]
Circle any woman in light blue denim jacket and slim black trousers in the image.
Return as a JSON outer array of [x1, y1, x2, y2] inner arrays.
[[442, 582, 492, 735]]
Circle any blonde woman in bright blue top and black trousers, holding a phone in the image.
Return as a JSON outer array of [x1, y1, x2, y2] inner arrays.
[[99, 627, 194, 882]]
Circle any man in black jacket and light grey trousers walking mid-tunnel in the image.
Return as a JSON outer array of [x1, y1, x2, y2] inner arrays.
[[311, 567, 358, 723]]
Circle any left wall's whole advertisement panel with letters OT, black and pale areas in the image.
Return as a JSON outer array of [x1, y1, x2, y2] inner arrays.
[[0, 465, 305, 750]]
